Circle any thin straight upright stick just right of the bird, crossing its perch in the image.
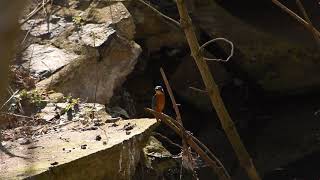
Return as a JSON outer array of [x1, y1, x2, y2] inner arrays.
[[160, 68, 194, 177]]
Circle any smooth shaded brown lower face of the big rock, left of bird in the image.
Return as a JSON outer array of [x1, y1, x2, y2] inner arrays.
[[37, 34, 141, 104]]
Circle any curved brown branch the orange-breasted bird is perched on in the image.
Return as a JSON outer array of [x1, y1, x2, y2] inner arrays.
[[145, 108, 231, 180]]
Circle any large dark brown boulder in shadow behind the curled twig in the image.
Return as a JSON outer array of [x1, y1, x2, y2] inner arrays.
[[194, 1, 320, 94]]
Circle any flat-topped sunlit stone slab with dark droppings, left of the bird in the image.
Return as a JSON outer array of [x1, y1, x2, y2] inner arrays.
[[0, 119, 157, 180]]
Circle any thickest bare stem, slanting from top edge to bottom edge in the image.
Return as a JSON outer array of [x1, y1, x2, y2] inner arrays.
[[176, 0, 261, 180]]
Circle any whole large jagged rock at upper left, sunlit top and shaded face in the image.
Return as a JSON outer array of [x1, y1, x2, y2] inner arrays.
[[37, 3, 142, 104]]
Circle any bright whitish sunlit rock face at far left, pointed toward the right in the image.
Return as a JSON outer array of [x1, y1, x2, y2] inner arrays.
[[22, 44, 78, 78]]
